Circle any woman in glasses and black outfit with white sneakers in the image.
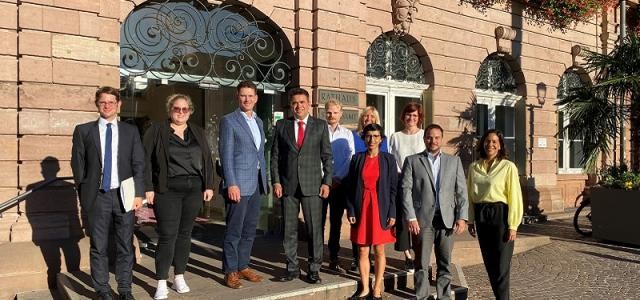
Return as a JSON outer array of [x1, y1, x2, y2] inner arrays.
[[143, 94, 213, 299]]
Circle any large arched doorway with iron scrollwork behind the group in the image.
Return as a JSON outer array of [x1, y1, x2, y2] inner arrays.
[[120, 0, 292, 223]]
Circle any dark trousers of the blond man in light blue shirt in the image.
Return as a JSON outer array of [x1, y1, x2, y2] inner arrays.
[[322, 185, 347, 262]]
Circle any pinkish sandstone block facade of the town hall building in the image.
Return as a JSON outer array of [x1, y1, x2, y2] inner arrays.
[[0, 0, 628, 232]]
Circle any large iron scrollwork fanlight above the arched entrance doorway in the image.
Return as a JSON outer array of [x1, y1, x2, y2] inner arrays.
[[120, 0, 291, 88]]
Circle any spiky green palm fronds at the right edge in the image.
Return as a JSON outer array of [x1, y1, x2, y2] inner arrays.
[[557, 31, 640, 171]]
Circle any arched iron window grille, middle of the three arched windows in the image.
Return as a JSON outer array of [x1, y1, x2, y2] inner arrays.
[[476, 55, 517, 93]]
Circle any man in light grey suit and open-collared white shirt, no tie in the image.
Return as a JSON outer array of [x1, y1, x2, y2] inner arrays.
[[402, 124, 469, 299]]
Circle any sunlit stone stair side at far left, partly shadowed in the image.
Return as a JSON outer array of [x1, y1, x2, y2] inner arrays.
[[0, 181, 89, 300]]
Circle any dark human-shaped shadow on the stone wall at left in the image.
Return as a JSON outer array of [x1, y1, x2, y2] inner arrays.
[[25, 156, 84, 289]]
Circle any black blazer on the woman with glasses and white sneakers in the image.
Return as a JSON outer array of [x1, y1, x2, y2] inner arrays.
[[143, 119, 214, 193]]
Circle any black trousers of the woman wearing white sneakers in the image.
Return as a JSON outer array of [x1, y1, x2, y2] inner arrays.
[[153, 176, 203, 280]]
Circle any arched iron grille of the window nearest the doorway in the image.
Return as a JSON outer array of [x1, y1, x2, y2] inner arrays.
[[367, 34, 425, 83]]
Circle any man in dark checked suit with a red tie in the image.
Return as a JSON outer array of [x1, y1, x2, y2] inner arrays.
[[271, 88, 333, 283]]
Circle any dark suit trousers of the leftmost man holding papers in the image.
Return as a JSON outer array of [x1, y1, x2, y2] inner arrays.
[[89, 189, 134, 294]]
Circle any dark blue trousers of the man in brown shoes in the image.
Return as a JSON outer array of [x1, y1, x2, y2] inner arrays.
[[222, 184, 262, 274]]
